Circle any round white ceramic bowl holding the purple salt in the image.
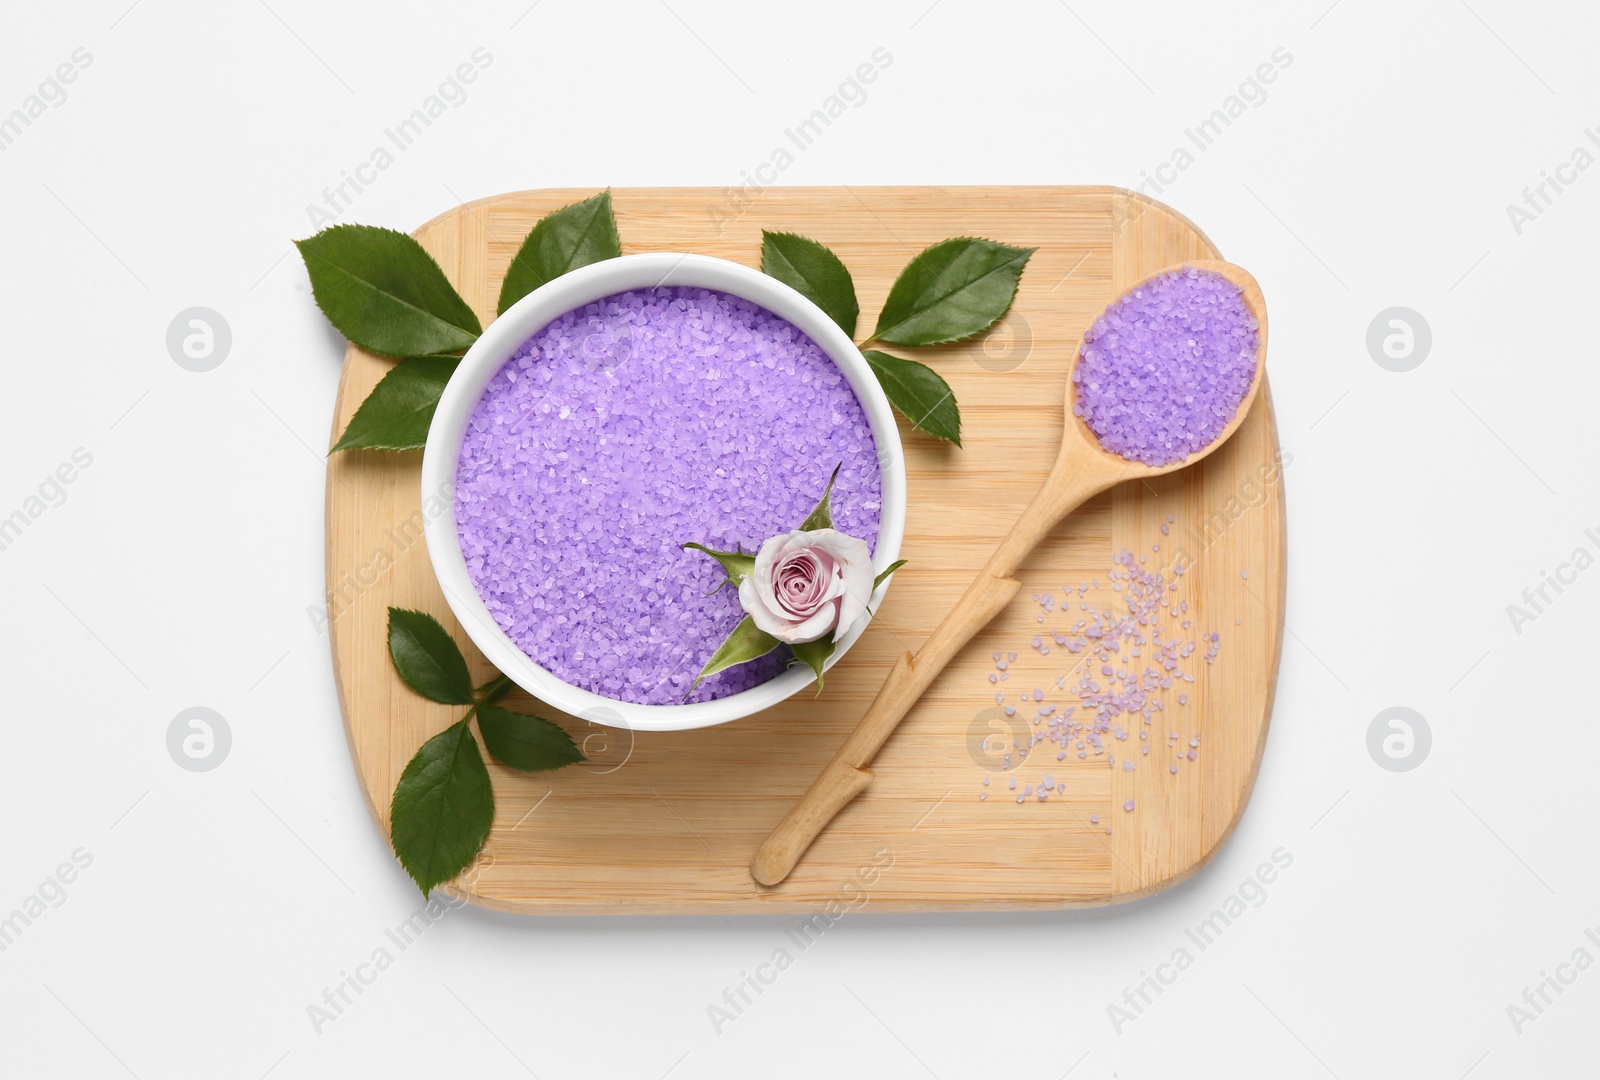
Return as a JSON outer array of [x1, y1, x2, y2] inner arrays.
[[422, 253, 906, 731]]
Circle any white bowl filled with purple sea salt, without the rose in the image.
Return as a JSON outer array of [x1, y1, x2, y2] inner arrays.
[[422, 254, 906, 730]]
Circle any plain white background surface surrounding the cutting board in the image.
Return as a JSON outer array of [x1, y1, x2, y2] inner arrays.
[[0, 0, 1600, 1080]]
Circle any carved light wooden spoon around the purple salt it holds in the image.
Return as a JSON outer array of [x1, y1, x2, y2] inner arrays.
[[750, 259, 1267, 885]]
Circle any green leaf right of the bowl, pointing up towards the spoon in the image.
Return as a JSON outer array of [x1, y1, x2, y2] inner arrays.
[[872, 237, 1034, 346]]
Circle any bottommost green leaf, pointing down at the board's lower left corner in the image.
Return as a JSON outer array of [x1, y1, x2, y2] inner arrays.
[[389, 720, 494, 896]]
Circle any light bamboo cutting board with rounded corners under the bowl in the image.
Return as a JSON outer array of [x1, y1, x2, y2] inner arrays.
[[326, 187, 1288, 914]]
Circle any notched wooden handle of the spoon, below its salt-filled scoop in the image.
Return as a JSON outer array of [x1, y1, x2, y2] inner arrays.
[[750, 454, 1118, 885]]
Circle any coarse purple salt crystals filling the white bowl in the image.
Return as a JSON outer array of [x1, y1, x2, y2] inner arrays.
[[456, 288, 882, 704]]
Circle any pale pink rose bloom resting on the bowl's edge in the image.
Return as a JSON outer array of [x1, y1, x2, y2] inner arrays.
[[739, 528, 872, 645]]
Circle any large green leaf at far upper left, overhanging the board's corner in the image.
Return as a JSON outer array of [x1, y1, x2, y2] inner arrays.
[[294, 226, 483, 357]]
